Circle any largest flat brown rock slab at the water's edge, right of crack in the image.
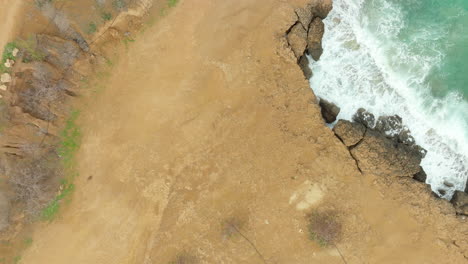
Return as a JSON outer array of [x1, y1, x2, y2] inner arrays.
[[351, 129, 421, 177]]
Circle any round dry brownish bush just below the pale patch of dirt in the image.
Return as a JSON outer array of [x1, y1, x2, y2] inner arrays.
[[308, 211, 341, 247]]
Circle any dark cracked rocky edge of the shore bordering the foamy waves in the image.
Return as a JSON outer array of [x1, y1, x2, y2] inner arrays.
[[286, 1, 468, 217]]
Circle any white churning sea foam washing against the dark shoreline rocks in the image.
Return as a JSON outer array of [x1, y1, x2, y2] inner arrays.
[[309, 0, 468, 199]]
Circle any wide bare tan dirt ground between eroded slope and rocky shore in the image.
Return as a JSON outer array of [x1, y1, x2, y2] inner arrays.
[[2, 0, 468, 264]]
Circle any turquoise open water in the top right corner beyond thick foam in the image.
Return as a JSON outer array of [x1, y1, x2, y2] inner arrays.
[[362, 0, 468, 100]]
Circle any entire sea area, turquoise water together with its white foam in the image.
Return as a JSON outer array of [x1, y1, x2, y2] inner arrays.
[[310, 0, 468, 199]]
